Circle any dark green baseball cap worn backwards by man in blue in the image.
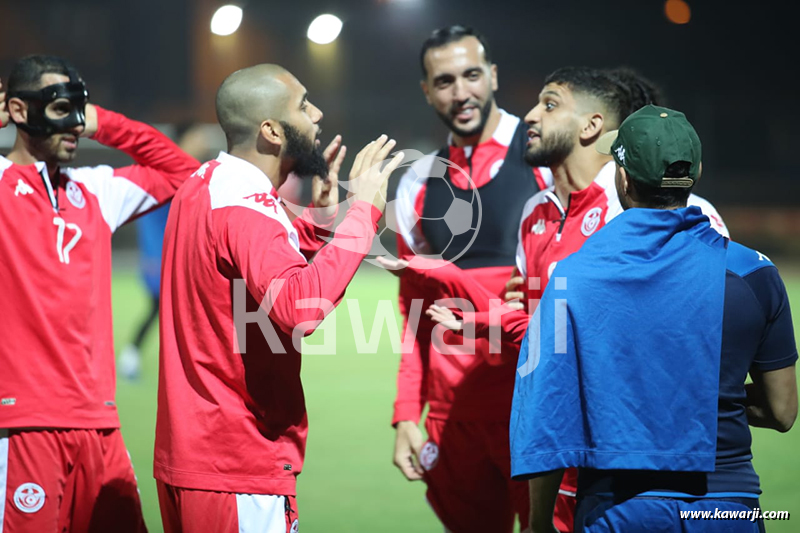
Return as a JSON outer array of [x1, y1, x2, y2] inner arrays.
[[595, 105, 702, 189]]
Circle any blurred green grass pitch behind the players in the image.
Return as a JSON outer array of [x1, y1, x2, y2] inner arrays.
[[113, 267, 800, 533]]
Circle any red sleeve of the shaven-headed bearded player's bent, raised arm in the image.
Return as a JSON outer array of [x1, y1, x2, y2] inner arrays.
[[213, 202, 381, 335]]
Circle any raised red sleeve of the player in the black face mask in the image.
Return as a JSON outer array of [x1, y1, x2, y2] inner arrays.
[[92, 106, 200, 205]]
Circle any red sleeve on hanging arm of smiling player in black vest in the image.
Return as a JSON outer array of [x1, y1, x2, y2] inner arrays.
[[392, 234, 433, 425]]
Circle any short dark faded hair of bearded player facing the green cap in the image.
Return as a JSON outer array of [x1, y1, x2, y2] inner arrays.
[[544, 67, 630, 126]]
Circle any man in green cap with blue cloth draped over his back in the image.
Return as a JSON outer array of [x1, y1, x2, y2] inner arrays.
[[510, 106, 797, 532]]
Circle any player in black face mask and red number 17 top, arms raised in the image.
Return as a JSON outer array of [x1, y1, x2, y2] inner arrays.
[[0, 56, 199, 532]]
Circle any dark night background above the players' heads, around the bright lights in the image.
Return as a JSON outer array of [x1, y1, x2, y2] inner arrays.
[[0, 0, 800, 206]]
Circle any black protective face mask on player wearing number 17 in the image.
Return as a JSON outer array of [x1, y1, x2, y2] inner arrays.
[[8, 72, 89, 137]]
